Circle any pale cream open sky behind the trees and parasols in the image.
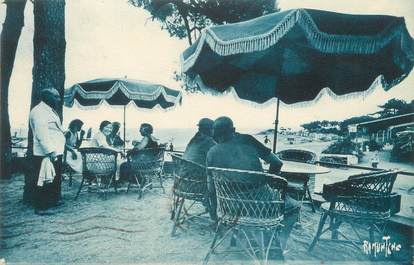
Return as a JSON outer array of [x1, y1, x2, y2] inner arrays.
[[0, 0, 414, 132]]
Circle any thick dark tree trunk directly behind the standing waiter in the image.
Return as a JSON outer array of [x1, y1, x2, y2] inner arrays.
[[23, 0, 66, 202]]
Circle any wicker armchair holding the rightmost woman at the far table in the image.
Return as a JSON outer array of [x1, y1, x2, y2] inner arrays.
[[127, 147, 165, 198]]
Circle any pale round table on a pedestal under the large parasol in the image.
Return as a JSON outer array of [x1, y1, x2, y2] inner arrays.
[[280, 160, 331, 194]]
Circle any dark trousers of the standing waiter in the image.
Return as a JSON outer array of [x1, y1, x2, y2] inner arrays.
[[32, 156, 62, 210]]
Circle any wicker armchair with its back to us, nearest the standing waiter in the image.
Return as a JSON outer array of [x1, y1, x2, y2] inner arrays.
[[75, 147, 118, 200]]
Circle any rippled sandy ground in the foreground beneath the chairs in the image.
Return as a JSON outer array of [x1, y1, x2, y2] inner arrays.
[[0, 171, 412, 264]]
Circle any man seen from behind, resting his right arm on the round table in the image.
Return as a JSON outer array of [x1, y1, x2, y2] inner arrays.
[[206, 117, 300, 251]]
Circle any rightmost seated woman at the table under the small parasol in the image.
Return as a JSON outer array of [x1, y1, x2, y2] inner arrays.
[[119, 123, 158, 182]]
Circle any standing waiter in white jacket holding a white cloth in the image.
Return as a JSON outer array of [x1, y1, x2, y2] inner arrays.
[[29, 88, 65, 213]]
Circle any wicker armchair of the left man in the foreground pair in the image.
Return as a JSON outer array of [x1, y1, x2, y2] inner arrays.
[[171, 154, 210, 236]]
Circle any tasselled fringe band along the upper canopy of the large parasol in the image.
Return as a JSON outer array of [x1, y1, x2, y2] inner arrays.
[[181, 9, 414, 72]]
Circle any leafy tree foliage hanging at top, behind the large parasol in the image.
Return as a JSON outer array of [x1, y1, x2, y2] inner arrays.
[[129, 0, 278, 45]]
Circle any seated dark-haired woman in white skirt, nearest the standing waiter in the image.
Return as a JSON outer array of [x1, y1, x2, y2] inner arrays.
[[64, 119, 85, 173]]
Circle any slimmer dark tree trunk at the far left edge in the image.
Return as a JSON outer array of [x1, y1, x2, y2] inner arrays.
[[0, 0, 26, 179]]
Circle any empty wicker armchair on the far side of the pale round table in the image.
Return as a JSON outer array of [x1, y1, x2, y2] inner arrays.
[[277, 149, 317, 212]]
